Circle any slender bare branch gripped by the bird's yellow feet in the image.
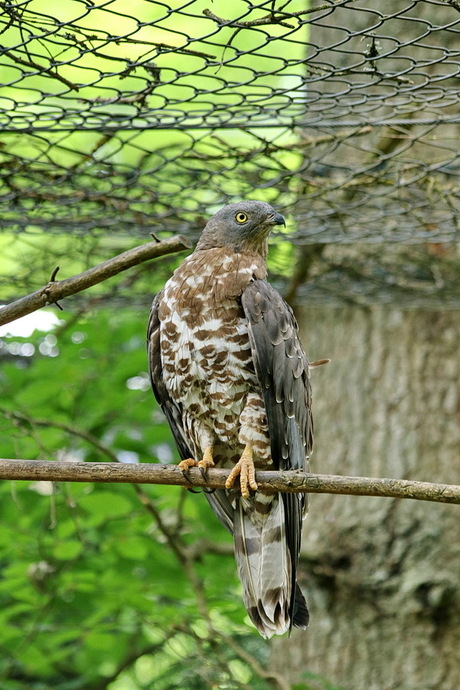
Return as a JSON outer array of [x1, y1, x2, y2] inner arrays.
[[0, 459, 460, 503]]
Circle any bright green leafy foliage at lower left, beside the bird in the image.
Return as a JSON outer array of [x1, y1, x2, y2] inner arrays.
[[0, 310, 278, 690]]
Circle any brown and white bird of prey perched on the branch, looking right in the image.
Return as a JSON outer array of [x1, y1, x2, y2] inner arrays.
[[147, 201, 315, 639]]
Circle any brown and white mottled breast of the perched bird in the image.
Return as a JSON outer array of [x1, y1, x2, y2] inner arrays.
[[159, 250, 259, 416]]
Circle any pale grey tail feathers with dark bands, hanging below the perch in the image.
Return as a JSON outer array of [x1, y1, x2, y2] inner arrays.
[[234, 496, 308, 638]]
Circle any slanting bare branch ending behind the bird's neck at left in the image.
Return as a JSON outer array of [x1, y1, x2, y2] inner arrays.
[[0, 235, 191, 326]]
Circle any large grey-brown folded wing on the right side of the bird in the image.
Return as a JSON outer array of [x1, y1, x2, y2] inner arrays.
[[241, 280, 313, 628]]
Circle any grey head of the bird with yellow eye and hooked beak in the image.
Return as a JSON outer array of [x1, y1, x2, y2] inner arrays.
[[196, 201, 286, 258]]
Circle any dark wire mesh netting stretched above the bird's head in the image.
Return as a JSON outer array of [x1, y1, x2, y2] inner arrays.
[[0, 0, 460, 300]]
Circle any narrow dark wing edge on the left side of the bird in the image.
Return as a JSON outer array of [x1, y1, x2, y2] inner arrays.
[[147, 292, 193, 460]]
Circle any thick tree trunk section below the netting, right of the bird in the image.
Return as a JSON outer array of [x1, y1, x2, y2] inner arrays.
[[272, 306, 460, 690]]
